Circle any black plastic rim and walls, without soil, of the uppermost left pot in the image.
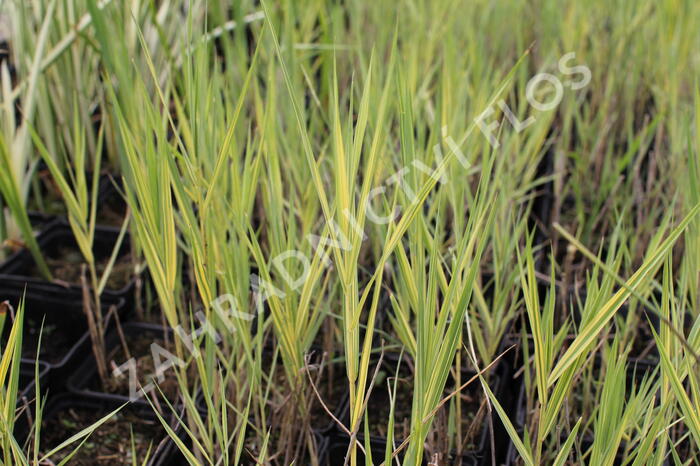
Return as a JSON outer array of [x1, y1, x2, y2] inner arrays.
[[0, 220, 135, 307]]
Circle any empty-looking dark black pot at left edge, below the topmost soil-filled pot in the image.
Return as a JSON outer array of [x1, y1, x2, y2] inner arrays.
[[0, 277, 124, 386]]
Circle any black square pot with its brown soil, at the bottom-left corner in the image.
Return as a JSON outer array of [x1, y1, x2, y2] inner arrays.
[[15, 394, 179, 466]]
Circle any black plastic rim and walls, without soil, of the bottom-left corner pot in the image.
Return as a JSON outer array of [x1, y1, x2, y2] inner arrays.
[[14, 393, 178, 466]]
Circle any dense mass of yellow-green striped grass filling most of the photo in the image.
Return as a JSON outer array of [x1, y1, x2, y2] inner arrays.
[[0, 0, 700, 465]]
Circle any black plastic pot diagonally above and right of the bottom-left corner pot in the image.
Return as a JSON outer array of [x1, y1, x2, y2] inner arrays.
[[66, 322, 178, 410]]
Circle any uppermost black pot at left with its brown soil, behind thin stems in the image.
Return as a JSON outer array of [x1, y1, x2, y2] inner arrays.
[[0, 219, 135, 304]]
